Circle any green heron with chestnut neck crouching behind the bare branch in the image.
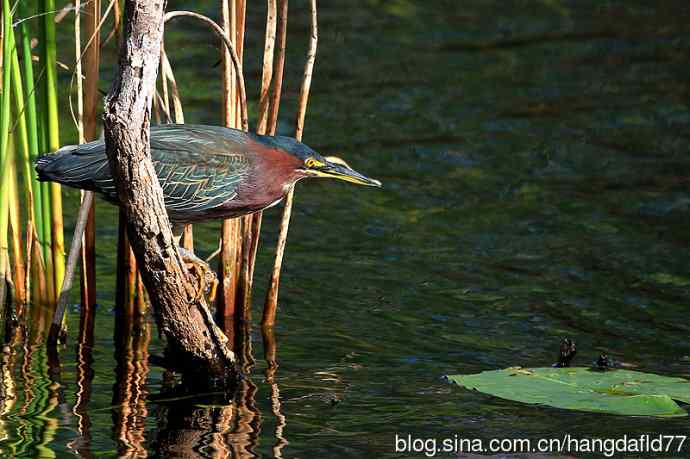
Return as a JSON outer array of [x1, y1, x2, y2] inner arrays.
[[36, 124, 381, 294]]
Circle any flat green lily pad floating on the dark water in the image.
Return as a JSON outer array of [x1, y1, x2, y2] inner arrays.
[[448, 367, 690, 416]]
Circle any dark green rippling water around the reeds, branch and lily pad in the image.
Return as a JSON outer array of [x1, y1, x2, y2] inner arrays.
[[0, 0, 690, 458]]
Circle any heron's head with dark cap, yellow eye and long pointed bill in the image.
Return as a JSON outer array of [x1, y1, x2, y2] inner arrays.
[[274, 136, 381, 187]]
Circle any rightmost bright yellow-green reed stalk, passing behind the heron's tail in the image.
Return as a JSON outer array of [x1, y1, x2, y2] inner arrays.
[[43, 0, 65, 302]]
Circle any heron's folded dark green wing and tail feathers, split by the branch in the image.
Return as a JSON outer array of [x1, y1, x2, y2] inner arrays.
[[37, 124, 252, 220]]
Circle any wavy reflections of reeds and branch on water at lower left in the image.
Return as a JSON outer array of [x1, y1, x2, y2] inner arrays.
[[0, 302, 288, 459]]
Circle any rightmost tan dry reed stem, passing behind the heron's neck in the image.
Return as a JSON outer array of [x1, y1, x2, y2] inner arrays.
[[262, 0, 319, 327]]
